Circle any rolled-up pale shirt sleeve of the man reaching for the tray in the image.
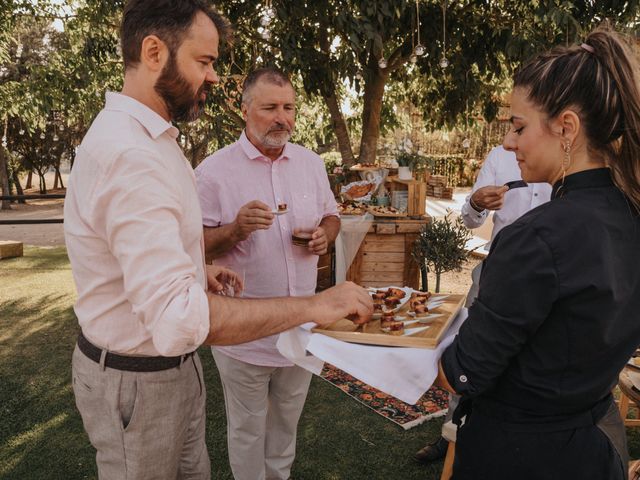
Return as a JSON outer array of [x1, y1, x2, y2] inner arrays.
[[93, 149, 209, 356]]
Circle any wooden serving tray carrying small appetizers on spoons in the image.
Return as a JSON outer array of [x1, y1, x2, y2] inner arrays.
[[312, 294, 465, 349]]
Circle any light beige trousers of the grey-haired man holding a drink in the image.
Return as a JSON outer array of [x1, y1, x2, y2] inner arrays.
[[212, 349, 312, 480]]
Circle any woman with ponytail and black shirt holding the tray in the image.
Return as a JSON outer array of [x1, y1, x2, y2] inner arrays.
[[440, 29, 640, 480]]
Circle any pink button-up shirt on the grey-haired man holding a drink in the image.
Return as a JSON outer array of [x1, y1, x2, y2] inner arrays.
[[196, 133, 338, 367]]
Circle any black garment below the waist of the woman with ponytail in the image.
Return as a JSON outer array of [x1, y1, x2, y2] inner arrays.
[[453, 411, 627, 480]]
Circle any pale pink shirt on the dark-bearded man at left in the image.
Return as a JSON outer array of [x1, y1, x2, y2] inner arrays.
[[64, 93, 209, 356]]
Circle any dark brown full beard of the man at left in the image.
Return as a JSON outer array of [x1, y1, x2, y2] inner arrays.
[[153, 53, 210, 122]]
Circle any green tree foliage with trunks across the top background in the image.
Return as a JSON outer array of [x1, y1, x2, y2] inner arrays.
[[0, 0, 640, 204]]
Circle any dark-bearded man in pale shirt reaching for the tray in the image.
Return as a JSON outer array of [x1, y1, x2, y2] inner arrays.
[[64, 0, 372, 480]]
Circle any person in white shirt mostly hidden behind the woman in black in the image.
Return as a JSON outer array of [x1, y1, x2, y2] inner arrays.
[[414, 145, 551, 463]]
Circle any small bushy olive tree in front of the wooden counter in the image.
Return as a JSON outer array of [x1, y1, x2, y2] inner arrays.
[[411, 215, 471, 293]]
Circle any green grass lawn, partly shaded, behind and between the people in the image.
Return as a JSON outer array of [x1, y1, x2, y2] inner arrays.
[[0, 247, 450, 480]]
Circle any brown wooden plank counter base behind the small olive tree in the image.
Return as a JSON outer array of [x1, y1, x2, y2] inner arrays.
[[347, 217, 430, 289]]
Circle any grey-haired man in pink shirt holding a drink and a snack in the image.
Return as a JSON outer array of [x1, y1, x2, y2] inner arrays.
[[196, 68, 340, 480]]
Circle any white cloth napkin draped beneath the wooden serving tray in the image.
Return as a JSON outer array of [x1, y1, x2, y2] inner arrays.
[[277, 308, 467, 404]]
